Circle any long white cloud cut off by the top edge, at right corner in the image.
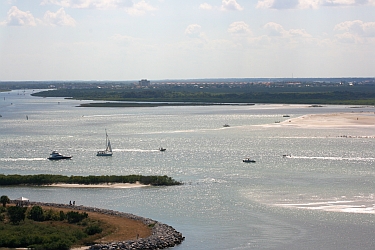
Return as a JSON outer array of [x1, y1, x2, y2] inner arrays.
[[257, 0, 375, 9]]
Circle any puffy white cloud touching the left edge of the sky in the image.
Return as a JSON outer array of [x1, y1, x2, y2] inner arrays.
[[1, 6, 38, 26]]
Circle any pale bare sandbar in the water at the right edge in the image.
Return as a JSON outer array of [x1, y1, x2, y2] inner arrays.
[[279, 112, 375, 128]]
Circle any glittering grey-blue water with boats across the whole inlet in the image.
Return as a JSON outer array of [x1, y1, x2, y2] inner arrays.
[[0, 90, 375, 250]]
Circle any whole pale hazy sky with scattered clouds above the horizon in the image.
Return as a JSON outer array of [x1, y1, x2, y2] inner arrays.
[[0, 0, 375, 81]]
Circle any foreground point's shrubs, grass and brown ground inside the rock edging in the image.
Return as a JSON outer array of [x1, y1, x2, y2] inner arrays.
[[0, 202, 152, 250]]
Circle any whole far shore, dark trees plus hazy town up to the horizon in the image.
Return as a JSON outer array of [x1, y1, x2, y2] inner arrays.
[[22, 78, 375, 107]]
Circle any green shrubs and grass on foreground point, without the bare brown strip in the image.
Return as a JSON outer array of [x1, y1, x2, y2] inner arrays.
[[0, 206, 106, 250]]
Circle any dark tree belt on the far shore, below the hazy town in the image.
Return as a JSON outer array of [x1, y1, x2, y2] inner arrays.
[[33, 87, 375, 105]]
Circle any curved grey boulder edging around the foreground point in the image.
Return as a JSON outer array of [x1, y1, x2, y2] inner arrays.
[[30, 202, 185, 250]]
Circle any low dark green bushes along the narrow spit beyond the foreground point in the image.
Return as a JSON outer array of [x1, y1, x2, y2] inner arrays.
[[0, 174, 182, 186]]
